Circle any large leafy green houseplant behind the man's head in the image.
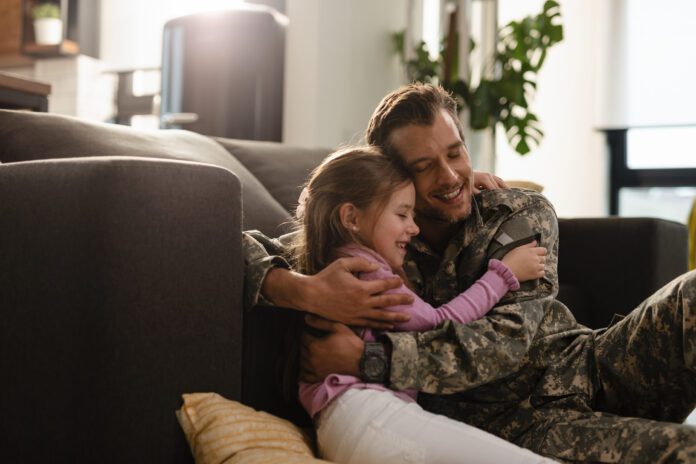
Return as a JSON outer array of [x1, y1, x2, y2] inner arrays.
[[392, 0, 563, 155]]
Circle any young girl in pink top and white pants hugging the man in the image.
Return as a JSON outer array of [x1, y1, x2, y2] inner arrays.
[[292, 147, 552, 463]]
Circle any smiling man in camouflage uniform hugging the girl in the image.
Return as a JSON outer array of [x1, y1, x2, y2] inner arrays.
[[245, 85, 696, 463]]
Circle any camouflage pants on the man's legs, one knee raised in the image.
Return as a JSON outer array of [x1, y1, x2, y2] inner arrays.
[[429, 272, 696, 464]]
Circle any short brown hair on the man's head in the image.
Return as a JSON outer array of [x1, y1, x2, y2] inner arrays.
[[365, 82, 464, 156]]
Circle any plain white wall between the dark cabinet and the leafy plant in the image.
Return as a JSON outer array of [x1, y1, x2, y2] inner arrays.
[[283, 0, 408, 147]]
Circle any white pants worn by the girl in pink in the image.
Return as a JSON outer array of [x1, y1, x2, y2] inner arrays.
[[317, 389, 555, 464]]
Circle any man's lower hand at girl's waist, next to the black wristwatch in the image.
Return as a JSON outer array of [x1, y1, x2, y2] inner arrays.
[[300, 314, 364, 383]]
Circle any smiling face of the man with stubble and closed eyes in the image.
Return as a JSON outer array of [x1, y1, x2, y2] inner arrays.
[[390, 110, 474, 224]]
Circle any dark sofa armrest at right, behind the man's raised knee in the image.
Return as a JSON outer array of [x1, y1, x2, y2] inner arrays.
[[558, 217, 688, 328]]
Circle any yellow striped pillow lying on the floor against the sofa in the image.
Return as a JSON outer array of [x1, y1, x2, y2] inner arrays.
[[176, 393, 326, 464]]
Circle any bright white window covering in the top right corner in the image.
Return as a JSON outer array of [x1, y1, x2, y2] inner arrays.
[[600, 0, 696, 127]]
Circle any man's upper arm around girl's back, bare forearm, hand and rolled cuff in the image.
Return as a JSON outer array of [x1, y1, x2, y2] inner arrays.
[[242, 231, 412, 329]]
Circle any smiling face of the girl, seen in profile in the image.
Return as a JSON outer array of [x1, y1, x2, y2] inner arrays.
[[358, 182, 420, 269]]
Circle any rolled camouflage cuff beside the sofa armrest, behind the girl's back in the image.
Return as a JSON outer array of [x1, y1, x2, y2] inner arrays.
[[242, 230, 290, 311]]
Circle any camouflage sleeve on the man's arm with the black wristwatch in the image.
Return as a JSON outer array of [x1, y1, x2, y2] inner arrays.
[[385, 196, 558, 394]]
